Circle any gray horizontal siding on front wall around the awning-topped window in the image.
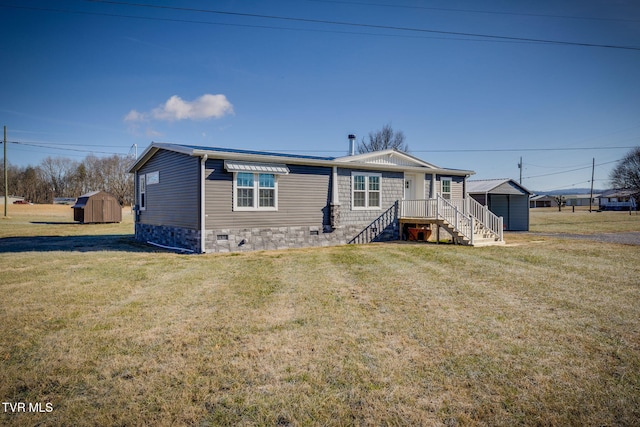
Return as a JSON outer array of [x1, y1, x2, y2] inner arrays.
[[205, 160, 331, 229]]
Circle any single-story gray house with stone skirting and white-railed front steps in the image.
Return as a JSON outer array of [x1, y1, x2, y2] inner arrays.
[[130, 142, 503, 253]]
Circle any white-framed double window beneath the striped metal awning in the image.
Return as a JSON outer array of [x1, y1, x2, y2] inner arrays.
[[233, 172, 278, 211]]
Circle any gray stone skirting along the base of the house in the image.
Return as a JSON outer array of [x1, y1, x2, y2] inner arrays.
[[135, 224, 399, 253]]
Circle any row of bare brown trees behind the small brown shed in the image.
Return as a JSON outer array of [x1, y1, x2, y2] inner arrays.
[[0, 154, 135, 206]]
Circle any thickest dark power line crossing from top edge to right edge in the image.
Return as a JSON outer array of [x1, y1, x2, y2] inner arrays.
[[84, 0, 640, 51]]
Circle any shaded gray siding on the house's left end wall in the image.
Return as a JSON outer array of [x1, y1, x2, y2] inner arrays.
[[136, 150, 200, 229]]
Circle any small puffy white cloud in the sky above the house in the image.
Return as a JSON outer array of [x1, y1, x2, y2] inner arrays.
[[124, 94, 233, 122]]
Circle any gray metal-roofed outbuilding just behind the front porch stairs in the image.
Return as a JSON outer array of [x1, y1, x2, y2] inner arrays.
[[467, 179, 532, 231]]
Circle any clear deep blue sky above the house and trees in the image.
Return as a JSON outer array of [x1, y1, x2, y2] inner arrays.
[[0, 0, 640, 191]]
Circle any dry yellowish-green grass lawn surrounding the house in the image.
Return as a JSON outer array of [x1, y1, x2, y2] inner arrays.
[[0, 206, 640, 426]]
